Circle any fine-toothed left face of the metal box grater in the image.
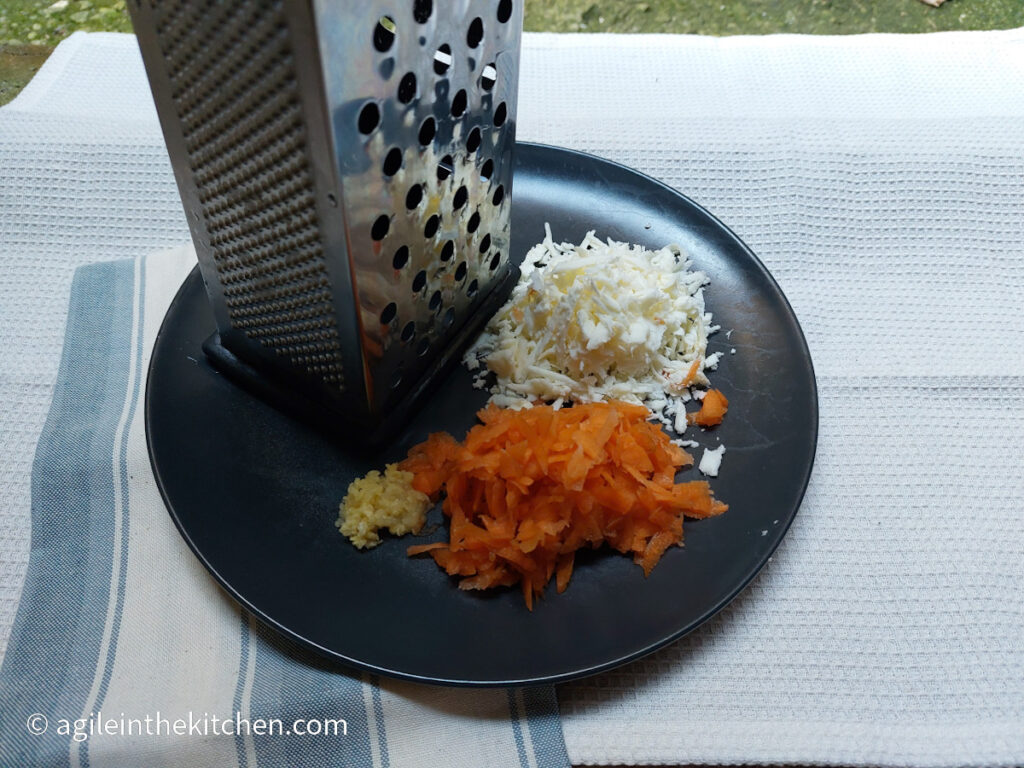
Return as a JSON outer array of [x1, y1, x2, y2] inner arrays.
[[153, 0, 343, 389]]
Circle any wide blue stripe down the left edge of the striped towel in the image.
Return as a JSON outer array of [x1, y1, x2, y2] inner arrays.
[[0, 261, 134, 767]]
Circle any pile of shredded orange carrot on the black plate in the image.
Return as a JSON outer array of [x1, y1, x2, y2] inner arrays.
[[399, 393, 728, 608]]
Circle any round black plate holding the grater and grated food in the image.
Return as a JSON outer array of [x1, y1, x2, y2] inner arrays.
[[145, 144, 817, 685]]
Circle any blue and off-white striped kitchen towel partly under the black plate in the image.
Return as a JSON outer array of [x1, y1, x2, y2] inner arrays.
[[0, 247, 568, 768]]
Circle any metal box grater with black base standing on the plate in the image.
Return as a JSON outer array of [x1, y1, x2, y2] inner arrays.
[[128, 0, 523, 437]]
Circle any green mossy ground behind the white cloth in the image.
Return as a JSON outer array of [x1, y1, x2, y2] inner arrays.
[[0, 0, 1024, 104]]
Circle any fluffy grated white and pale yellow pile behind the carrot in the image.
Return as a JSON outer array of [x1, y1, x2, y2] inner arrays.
[[464, 224, 718, 433]]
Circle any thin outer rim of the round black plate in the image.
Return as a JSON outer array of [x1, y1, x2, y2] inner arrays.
[[143, 141, 820, 688]]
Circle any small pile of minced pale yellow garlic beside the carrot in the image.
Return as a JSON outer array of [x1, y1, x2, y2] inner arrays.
[[335, 464, 430, 549]]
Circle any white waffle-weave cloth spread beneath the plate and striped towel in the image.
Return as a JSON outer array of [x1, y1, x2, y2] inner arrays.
[[0, 30, 1024, 766]]
